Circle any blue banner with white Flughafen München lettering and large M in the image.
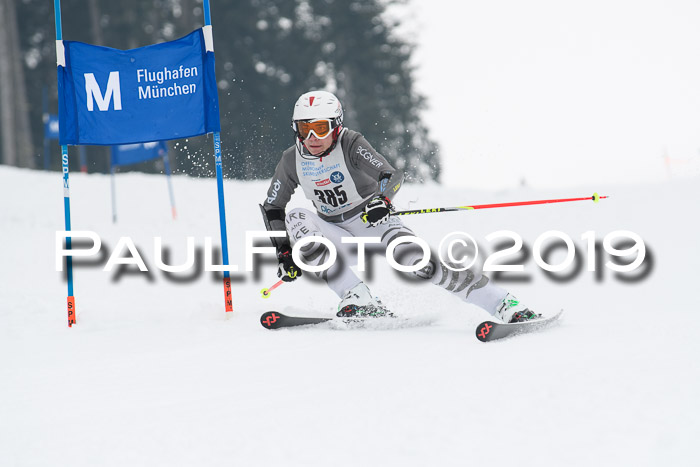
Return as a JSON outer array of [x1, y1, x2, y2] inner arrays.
[[58, 29, 221, 145]]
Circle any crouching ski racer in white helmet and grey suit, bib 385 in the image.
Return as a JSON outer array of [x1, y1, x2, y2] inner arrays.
[[261, 91, 540, 323]]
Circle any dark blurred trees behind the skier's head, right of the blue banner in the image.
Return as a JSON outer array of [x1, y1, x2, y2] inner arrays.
[[212, 0, 440, 181]]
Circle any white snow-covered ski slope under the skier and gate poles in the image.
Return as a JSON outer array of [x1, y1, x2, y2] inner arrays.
[[0, 167, 700, 466]]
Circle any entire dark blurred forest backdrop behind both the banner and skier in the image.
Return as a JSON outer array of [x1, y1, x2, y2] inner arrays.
[[9, 0, 440, 181]]
